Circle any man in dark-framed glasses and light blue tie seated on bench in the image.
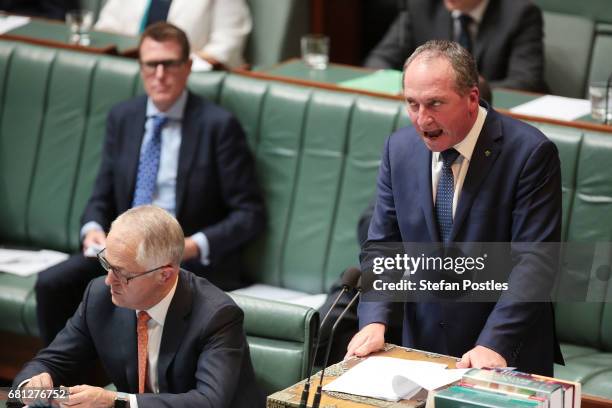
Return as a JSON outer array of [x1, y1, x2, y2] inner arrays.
[[36, 23, 265, 344]]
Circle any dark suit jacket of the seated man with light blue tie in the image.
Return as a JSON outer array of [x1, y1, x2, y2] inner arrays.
[[82, 93, 265, 290]]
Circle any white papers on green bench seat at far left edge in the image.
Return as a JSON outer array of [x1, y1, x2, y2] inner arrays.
[[0, 248, 69, 276]]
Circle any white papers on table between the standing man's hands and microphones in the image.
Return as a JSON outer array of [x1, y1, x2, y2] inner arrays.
[[323, 357, 468, 401]]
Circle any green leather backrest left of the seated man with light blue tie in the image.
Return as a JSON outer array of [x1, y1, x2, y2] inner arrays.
[[0, 41, 138, 251]]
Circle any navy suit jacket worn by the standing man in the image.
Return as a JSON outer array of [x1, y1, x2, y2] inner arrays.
[[359, 105, 562, 375]]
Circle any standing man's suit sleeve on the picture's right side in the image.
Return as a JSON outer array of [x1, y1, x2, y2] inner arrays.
[[477, 140, 561, 364]]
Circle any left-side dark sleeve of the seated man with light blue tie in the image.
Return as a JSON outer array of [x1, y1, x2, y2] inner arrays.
[[81, 110, 118, 231]]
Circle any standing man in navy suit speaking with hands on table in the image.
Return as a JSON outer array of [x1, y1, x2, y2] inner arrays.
[[348, 41, 562, 375]]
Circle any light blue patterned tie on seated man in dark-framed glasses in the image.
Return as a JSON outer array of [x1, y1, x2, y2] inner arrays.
[[132, 116, 168, 207]]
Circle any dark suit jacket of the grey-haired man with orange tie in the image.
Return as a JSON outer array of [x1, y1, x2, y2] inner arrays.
[[14, 270, 264, 408]]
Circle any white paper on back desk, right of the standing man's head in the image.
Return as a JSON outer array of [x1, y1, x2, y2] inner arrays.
[[510, 95, 591, 120]]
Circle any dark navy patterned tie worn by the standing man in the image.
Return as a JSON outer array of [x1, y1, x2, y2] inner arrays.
[[436, 148, 459, 242]]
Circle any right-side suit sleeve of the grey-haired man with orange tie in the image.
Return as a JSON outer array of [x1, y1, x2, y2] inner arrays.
[[136, 305, 251, 408]]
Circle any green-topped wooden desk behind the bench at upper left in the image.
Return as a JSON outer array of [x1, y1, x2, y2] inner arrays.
[[0, 18, 138, 57]]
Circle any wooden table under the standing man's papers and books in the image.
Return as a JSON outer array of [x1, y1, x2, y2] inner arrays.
[[266, 344, 612, 408]]
